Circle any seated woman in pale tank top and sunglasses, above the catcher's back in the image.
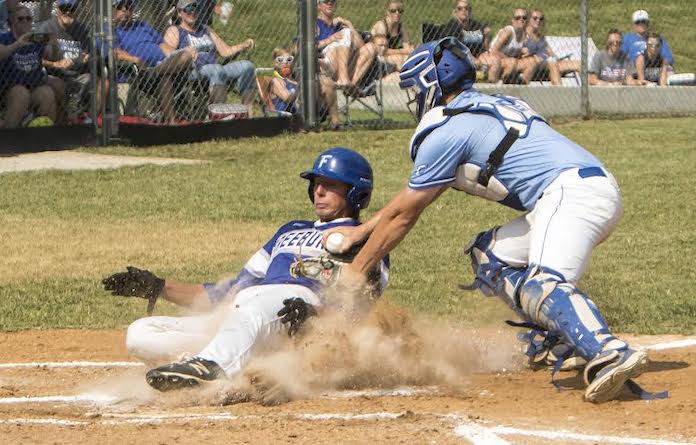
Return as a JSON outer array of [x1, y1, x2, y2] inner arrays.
[[488, 8, 538, 83]]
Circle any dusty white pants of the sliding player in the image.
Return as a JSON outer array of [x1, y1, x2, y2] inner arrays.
[[126, 284, 321, 377]]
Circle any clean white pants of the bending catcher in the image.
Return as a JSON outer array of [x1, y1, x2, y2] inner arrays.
[[491, 168, 623, 285]]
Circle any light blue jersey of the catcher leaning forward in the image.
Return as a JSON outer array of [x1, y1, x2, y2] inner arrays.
[[409, 89, 602, 210]]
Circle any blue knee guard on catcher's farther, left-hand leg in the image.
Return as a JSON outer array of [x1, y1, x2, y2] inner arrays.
[[464, 227, 527, 310]]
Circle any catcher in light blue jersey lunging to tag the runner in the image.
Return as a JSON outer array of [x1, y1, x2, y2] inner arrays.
[[325, 38, 664, 403]]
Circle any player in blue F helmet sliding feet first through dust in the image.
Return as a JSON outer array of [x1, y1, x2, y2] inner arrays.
[[103, 148, 389, 391]]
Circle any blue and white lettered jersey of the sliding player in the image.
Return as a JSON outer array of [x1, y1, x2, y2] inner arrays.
[[204, 218, 389, 303]]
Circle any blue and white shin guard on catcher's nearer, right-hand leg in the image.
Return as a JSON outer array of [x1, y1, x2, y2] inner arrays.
[[520, 267, 628, 360]]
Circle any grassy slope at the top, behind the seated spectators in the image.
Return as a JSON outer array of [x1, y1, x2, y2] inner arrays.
[[198, 0, 696, 72]]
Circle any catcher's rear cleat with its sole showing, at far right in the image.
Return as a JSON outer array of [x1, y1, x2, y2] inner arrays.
[[584, 349, 648, 403]]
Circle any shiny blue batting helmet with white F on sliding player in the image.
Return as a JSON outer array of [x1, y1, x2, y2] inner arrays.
[[300, 147, 372, 212]]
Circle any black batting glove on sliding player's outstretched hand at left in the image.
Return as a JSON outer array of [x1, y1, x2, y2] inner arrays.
[[102, 266, 164, 315]]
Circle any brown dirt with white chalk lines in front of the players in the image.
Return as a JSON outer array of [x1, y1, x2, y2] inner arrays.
[[0, 330, 696, 444]]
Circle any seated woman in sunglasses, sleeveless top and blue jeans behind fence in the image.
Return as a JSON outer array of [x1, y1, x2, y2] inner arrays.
[[164, 0, 256, 112]]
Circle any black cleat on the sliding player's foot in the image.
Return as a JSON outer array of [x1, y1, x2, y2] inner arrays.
[[145, 357, 225, 391]]
